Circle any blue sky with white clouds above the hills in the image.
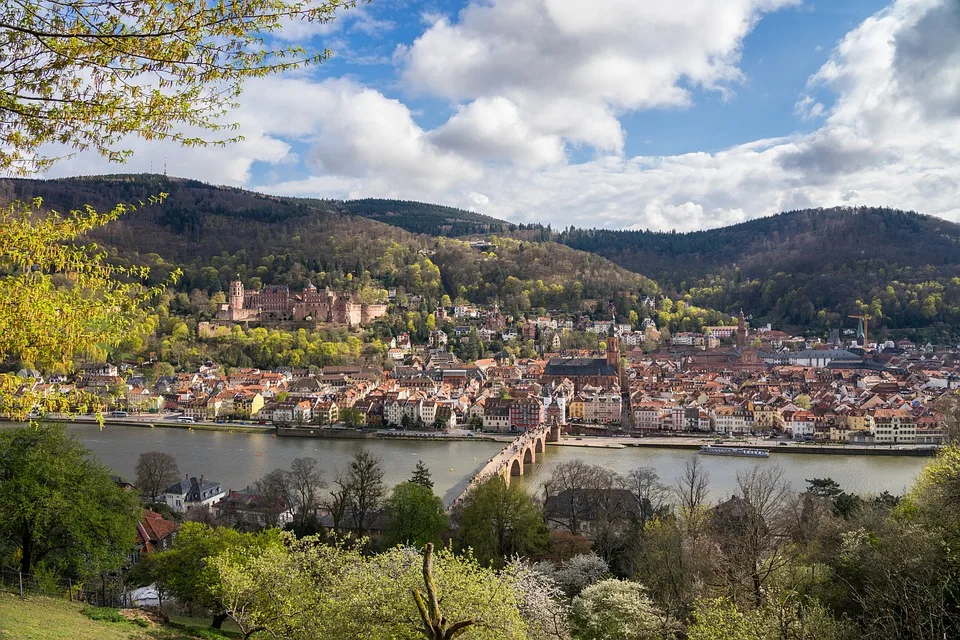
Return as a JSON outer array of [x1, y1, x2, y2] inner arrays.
[[48, 0, 960, 231]]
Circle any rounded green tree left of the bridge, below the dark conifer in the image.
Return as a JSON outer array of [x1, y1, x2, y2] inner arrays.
[[385, 481, 447, 547]]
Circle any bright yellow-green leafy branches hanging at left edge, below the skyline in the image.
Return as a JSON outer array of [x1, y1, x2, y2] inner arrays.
[[0, 198, 172, 419]]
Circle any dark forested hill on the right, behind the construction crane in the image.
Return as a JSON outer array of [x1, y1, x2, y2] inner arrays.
[[553, 208, 960, 338]]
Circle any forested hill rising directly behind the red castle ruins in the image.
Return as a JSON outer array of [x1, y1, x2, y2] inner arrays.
[[0, 175, 658, 314]]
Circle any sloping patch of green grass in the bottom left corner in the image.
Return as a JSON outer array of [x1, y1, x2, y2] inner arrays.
[[0, 593, 234, 640]]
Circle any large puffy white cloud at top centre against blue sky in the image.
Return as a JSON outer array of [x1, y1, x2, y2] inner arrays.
[[396, 0, 799, 157]]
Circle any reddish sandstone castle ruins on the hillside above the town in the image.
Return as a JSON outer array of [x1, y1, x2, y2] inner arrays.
[[217, 280, 387, 327]]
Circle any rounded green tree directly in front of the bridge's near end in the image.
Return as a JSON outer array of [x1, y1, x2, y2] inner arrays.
[[455, 476, 547, 566]]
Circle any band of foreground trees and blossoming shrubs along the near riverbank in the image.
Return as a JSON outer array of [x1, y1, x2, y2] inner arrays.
[[0, 425, 960, 640]]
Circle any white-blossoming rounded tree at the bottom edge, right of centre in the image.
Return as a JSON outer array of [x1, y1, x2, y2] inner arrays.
[[570, 579, 675, 640]]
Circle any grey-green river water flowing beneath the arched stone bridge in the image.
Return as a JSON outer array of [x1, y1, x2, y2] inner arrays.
[[15, 424, 929, 502]]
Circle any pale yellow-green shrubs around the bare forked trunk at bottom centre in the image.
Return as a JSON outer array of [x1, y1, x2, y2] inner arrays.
[[211, 538, 527, 640]]
